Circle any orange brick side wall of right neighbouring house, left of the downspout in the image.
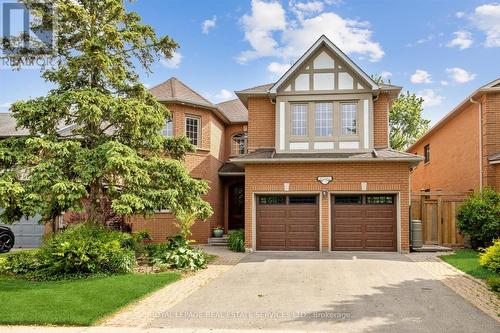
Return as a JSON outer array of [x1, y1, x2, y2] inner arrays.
[[411, 104, 479, 192]]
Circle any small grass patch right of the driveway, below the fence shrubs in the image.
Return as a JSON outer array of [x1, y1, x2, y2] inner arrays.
[[440, 249, 500, 280]]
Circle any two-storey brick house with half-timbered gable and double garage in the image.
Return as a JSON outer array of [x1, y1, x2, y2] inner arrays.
[[0, 36, 421, 252]]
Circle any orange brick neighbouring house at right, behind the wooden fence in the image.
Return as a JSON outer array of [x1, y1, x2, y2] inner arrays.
[[407, 78, 500, 192]]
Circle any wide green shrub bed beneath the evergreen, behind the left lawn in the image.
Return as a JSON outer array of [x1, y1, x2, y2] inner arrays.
[[1, 223, 136, 280]]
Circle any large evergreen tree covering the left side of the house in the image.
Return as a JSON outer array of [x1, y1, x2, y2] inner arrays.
[[0, 0, 211, 226]]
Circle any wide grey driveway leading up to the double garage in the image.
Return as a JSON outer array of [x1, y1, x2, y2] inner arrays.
[[150, 253, 500, 332]]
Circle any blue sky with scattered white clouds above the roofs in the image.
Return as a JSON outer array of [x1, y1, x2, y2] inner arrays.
[[0, 0, 500, 123]]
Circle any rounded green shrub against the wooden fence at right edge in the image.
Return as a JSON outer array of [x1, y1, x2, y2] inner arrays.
[[457, 188, 500, 248]]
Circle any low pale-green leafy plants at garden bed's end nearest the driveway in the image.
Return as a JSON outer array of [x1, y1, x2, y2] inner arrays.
[[146, 235, 207, 271]]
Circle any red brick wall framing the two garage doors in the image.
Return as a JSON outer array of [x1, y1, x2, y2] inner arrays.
[[245, 162, 409, 251]]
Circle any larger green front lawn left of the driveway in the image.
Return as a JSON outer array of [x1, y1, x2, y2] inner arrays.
[[0, 272, 180, 325]]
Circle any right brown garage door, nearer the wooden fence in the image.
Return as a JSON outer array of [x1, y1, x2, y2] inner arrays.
[[331, 194, 397, 251]]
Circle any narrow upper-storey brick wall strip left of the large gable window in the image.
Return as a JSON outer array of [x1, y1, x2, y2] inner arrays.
[[248, 97, 276, 151]]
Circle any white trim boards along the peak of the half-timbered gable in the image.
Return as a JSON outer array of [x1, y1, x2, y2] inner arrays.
[[269, 35, 380, 94]]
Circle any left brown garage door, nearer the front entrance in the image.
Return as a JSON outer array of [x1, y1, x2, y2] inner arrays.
[[256, 195, 319, 251]]
